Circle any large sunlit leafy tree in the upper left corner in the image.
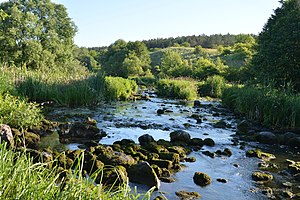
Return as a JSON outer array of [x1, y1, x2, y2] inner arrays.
[[0, 0, 76, 68]]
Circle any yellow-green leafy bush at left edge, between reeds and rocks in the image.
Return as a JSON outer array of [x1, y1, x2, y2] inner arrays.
[[0, 94, 43, 128]]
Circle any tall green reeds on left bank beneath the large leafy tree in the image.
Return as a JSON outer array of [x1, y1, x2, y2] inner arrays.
[[1, 66, 104, 106]]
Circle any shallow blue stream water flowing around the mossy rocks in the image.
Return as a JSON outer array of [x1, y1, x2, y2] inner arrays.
[[43, 98, 299, 200]]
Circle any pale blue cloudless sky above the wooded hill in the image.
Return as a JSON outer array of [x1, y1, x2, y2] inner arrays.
[[0, 0, 280, 47]]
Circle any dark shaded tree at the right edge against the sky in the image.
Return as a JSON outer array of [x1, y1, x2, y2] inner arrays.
[[252, 0, 300, 91]]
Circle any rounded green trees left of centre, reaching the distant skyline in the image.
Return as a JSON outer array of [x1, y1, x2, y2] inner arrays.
[[101, 40, 150, 78]]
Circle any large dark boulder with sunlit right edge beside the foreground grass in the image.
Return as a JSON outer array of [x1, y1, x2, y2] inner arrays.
[[128, 162, 160, 189]]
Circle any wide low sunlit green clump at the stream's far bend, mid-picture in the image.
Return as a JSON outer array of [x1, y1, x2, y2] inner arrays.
[[157, 79, 197, 100]]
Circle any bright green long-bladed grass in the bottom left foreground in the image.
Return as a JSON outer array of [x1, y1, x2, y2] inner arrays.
[[0, 144, 150, 200]]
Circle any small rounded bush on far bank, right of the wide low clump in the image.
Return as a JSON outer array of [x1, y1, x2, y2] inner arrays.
[[198, 75, 226, 98]]
